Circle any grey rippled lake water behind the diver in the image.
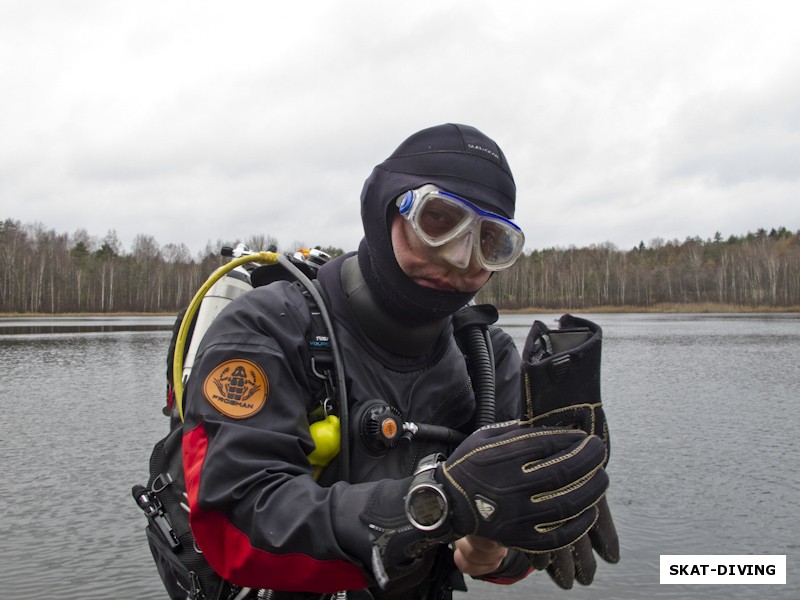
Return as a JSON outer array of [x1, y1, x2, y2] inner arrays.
[[0, 314, 800, 600]]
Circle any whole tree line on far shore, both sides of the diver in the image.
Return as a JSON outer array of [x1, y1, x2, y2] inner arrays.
[[0, 219, 800, 314]]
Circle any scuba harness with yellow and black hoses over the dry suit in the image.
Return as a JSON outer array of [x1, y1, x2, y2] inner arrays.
[[132, 247, 498, 600]]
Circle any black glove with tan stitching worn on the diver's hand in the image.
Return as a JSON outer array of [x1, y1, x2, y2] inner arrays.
[[435, 422, 608, 552]]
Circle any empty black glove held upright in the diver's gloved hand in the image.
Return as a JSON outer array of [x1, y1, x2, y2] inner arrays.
[[522, 315, 619, 589]]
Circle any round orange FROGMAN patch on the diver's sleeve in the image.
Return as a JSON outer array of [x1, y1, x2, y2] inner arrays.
[[203, 359, 269, 419]]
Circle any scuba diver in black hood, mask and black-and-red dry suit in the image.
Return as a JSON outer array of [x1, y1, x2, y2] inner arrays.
[[144, 124, 618, 599]]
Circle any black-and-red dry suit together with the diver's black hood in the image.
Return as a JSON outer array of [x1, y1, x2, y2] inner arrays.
[[183, 125, 527, 599]]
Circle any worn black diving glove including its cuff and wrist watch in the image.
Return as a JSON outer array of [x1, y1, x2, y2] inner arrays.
[[361, 421, 608, 587]]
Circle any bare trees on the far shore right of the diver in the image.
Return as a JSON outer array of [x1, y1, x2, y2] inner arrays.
[[481, 227, 800, 309]]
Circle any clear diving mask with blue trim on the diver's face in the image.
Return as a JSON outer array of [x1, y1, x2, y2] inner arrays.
[[397, 185, 525, 271]]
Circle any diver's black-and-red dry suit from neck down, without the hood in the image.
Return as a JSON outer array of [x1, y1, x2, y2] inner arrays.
[[183, 257, 520, 598]]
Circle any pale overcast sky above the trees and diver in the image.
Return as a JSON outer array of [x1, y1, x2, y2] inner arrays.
[[0, 0, 800, 254]]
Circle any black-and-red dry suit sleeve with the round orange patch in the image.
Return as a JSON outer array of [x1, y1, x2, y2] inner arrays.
[[183, 284, 408, 593]]
